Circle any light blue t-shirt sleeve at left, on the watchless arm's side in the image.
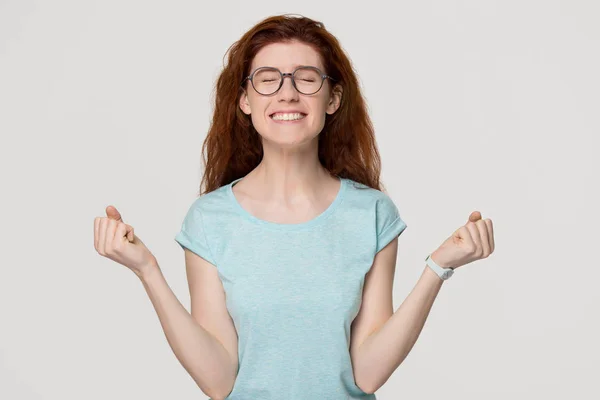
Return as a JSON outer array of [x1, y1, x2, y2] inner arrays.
[[175, 200, 216, 265]]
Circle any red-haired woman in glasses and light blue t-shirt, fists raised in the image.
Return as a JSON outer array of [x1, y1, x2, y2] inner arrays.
[[95, 15, 493, 399]]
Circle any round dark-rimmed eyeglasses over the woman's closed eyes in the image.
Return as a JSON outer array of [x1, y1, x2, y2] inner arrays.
[[242, 66, 335, 96]]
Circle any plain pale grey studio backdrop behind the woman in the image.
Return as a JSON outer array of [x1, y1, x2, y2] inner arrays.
[[0, 0, 600, 400]]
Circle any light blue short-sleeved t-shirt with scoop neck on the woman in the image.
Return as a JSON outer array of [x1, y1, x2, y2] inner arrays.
[[175, 178, 406, 400]]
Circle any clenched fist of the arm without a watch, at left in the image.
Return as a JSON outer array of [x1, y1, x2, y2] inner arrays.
[[94, 206, 158, 278]]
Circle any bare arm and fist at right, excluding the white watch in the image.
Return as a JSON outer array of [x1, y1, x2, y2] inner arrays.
[[351, 211, 495, 392]]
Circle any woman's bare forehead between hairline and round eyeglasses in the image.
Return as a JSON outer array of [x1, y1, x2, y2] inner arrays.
[[250, 41, 323, 72]]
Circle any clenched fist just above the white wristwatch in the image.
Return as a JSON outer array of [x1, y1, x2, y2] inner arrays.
[[431, 211, 494, 269]]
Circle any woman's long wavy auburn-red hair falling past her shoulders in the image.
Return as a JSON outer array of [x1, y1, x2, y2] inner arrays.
[[199, 14, 383, 195]]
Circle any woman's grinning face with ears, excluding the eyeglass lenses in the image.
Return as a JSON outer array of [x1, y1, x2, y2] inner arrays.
[[239, 41, 342, 146]]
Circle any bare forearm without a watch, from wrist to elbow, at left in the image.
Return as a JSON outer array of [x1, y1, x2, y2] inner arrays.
[[140, 265, 237, 399]]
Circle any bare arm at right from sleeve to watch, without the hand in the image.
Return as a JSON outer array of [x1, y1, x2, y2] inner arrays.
[[352, 240, 443, 393]]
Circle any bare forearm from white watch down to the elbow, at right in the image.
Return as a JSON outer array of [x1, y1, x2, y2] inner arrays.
[[355, 266, 443, 392]]
